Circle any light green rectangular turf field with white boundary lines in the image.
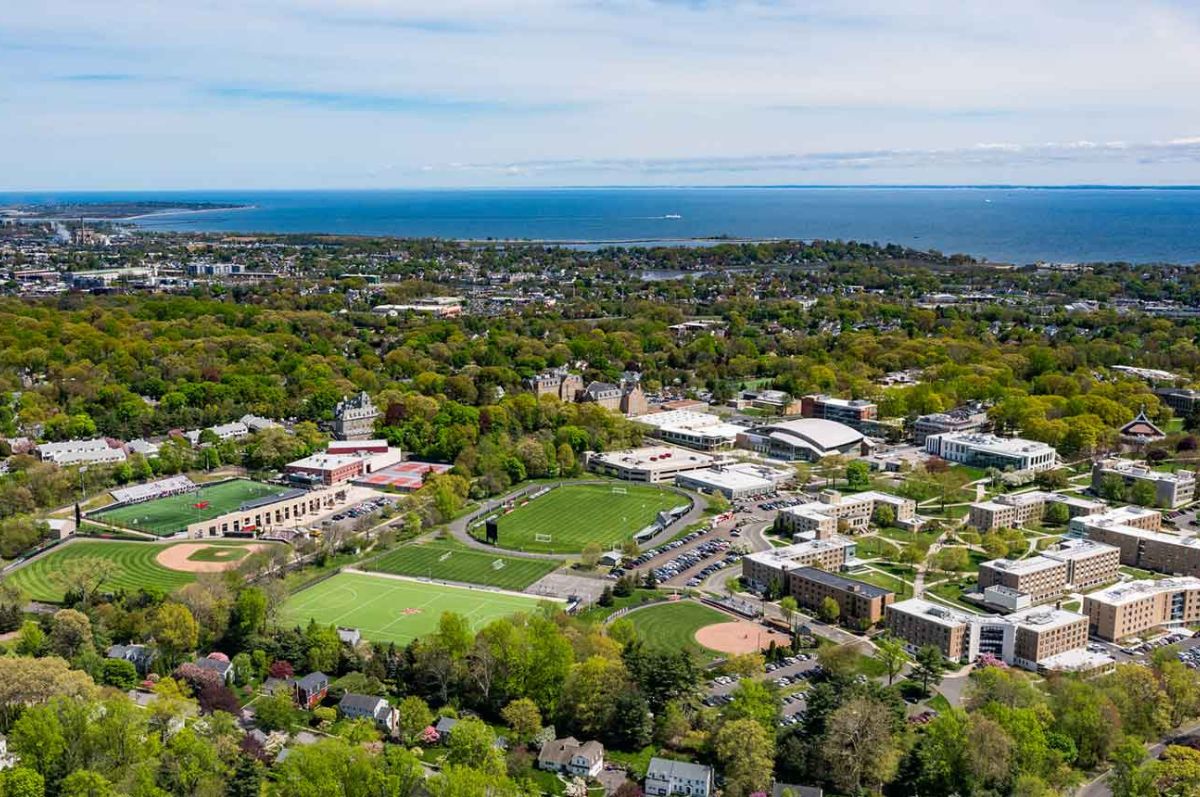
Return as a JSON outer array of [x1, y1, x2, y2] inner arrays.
[[281, 573, 539, 645]]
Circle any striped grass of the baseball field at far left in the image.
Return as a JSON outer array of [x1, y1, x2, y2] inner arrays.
[[5, 540, 258, 603]]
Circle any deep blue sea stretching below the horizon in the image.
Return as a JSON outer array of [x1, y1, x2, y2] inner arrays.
[[0, 187, 1200, 264]]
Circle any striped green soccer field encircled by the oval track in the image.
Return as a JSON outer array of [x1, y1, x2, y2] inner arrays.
[[474, 484, 688, 553]]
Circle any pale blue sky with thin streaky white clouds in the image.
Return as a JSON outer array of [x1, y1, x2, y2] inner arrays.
[[0, 0, 1200, 190]]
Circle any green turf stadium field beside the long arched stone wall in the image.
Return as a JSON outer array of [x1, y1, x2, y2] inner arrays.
[[90, 479, 286, 537]]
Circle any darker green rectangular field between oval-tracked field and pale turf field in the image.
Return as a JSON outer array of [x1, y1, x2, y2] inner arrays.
[[362, 540, 559, 592]]
